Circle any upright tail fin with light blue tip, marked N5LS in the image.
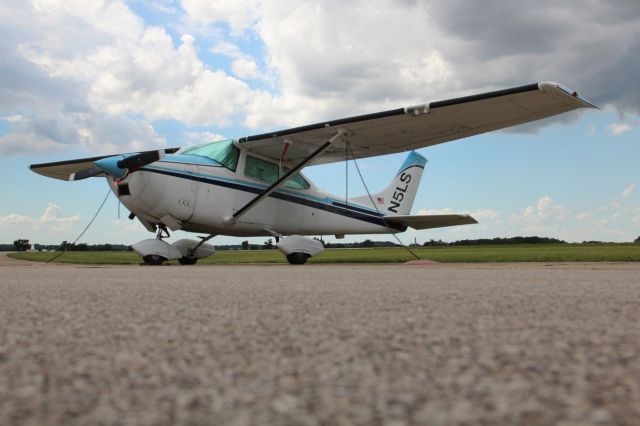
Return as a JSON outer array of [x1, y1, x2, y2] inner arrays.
[[350, 151, 427, 216]]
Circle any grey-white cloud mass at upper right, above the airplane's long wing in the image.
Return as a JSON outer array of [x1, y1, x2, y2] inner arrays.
[[176, 0, 640, 131]]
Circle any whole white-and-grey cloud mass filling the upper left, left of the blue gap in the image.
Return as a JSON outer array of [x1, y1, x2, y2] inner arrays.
[[0, 0, 257, 155]]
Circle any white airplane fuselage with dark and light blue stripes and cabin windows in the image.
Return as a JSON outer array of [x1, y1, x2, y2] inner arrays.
[[107, 142, 406, 236]]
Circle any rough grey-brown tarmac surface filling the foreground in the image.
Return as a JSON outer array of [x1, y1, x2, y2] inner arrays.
[[0, 255, 640, 426]]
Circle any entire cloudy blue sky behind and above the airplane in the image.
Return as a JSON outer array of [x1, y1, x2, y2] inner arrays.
[[0, 0, 640, 244]]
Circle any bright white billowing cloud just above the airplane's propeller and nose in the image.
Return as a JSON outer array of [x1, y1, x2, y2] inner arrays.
[[23, 27, 258, 126]]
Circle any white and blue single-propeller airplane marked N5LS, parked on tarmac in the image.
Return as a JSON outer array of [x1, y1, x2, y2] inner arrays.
[[30, 82, 597, 265]]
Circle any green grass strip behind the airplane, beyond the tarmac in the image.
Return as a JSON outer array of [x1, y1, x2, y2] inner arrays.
[[9, 243, 640, 265]]
